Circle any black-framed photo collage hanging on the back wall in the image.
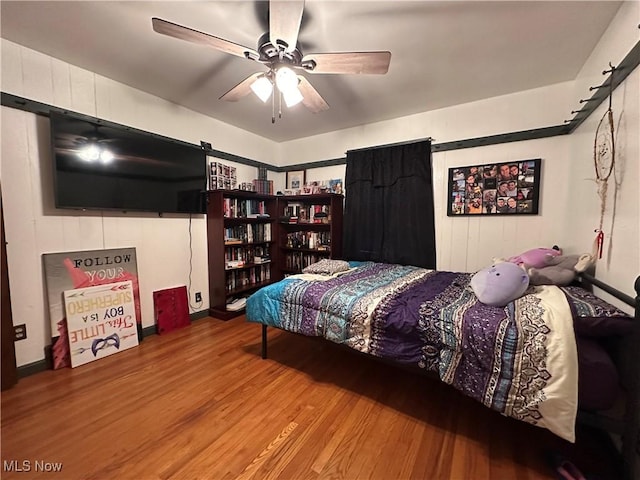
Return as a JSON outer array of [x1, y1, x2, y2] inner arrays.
[[447, 158, 542, 217]]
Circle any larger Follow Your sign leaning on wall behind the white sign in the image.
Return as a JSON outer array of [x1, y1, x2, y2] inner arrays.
[[42, 248, 142, 369]]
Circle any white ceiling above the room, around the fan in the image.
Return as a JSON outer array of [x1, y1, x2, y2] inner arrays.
[[0, 0, 621, 142]]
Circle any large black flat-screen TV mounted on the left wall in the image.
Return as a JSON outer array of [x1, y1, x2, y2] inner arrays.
[[49, 111, 207, 213]]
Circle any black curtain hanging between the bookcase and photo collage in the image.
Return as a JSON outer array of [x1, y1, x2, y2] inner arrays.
[[343, 141, 436, 269]]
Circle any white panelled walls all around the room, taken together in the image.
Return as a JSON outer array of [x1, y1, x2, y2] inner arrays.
[[0, 2, 640, 366]]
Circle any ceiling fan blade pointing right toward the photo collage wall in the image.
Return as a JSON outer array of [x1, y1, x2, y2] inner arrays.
[[302, 52, 391, 75]]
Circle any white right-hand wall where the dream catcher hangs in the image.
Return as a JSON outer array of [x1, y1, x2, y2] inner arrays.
[[563, 2, 640, 310]]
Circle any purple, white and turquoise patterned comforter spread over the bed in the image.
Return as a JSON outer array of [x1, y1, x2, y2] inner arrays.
[[246, 262, 578, 442]]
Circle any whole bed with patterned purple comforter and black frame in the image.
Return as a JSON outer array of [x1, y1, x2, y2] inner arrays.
[[246, 261, 640, 479]]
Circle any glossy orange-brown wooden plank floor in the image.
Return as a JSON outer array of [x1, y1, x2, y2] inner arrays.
[[1, 317, 616, 480]]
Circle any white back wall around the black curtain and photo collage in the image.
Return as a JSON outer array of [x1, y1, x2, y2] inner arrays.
[[278, 83, 574, 271]]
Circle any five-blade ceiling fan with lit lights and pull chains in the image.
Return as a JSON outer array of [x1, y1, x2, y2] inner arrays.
[[152, 0, 391, 123]]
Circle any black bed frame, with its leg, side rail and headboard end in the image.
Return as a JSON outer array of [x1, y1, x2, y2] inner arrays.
[[261, 273, 640, 480]]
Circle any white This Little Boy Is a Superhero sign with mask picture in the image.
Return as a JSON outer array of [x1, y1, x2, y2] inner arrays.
[[64, 280, 138, 367]]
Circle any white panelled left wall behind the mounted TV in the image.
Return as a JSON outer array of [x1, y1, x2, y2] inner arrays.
[[0, 39, 276, 366]]
